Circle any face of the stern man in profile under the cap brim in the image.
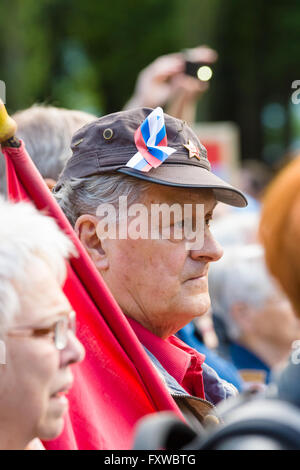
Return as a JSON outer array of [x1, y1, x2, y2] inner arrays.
[[98, 184, 222, 338]]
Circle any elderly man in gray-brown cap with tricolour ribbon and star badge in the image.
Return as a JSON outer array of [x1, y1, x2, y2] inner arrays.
[[54, 108, 247, 426]]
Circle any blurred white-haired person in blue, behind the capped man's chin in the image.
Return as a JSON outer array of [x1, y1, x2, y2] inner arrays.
[[209, 244, 300, 390]]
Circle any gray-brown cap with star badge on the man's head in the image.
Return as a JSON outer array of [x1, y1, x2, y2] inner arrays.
[[54, 108, 247, 207]]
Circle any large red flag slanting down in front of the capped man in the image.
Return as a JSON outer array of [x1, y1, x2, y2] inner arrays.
[[2, 143, 183, 450]]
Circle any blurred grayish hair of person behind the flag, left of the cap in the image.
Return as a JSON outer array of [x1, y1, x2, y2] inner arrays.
[[0, 104, 97, 193]]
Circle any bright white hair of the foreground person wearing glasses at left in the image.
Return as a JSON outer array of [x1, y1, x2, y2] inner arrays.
[[0, 198, 76, 331]]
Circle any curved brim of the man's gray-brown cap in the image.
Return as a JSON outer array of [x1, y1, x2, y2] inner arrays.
[[118, 163, 248, 207]]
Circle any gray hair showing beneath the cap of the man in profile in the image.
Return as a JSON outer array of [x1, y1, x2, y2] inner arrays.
[[54, 173, 153, 227]]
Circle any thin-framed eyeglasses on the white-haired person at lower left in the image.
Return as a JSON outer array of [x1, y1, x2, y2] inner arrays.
[[6, 310, 76, 351]]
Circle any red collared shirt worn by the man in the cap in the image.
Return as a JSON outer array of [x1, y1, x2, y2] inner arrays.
[[127, 317, 205, 399]]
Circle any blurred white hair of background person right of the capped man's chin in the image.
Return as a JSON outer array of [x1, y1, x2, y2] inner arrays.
[[209, 244, 276, 340]]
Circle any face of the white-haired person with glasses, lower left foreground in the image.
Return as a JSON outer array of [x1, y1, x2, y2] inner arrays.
[[0, 261, 84, 448]]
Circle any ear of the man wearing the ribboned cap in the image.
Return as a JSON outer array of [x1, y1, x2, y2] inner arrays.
[[74, 214, 109, 272]]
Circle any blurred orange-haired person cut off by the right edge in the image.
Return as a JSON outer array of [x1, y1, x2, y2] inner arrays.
[[259, 156, 300, 406]]
